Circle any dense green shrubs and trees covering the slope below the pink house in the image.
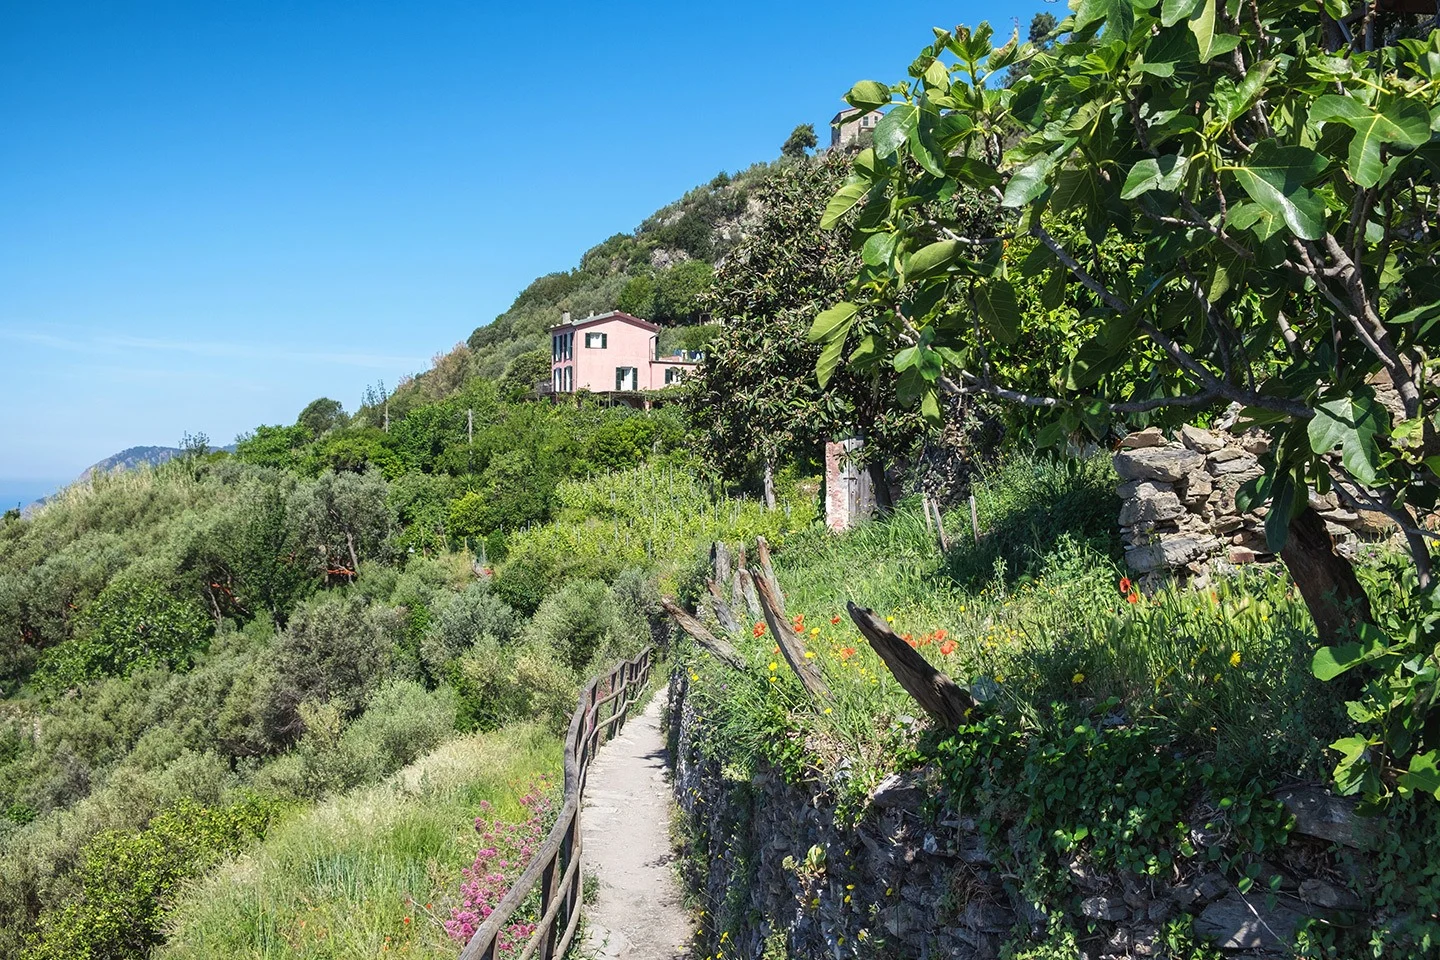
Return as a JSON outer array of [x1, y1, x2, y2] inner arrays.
[[0, 380, 754, 956]]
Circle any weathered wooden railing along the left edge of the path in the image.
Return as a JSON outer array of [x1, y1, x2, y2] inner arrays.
[[459, 648, 654, 960]]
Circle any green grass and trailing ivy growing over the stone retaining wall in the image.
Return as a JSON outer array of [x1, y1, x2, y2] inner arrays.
[[687, 456, 1440, 960]]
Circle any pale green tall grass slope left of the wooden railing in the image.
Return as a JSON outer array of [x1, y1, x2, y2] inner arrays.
[[156, 724, 562, 960]]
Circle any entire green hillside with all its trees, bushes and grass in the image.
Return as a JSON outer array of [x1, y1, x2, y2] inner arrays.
[[8, 0, 1440, 960]]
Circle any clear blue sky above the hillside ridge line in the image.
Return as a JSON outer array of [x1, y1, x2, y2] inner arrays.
[[0, 0, 1056, 486]]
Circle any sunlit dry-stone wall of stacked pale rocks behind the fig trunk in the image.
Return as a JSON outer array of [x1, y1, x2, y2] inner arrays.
[[1115, 426, 1388, 584]]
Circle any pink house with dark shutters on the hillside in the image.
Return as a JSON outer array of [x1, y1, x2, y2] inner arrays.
[[550, 309, 698, 393]]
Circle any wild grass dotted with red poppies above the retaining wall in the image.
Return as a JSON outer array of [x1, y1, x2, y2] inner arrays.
[[693, 456, 1344, 792]]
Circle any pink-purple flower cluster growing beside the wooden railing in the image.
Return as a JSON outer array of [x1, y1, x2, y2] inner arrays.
[[445, 780, 553, 956]]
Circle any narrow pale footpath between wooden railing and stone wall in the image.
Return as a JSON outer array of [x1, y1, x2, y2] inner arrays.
[[580, 695, 691, 960]]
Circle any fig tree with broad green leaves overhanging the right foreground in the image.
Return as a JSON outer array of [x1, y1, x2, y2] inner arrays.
[[811, 0, 1440, 792]]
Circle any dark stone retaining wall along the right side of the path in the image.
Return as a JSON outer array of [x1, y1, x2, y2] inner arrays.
[[667, 672, 1393, 960]]
